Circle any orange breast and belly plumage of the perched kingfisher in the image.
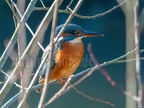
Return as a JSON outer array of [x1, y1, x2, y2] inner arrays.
[[49, 42, 84, 81]]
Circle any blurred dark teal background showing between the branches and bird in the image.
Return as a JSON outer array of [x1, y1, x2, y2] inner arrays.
[[0, 0, 144, 108]]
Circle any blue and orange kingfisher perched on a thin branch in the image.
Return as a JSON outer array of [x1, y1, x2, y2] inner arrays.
[[37, 23, 103, 92]]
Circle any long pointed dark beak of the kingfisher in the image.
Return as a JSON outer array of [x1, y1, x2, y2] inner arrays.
[[80, 30, 104, 37]]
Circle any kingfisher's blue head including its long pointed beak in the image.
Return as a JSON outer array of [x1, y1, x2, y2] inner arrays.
[[55, 24, 103, 41]]
